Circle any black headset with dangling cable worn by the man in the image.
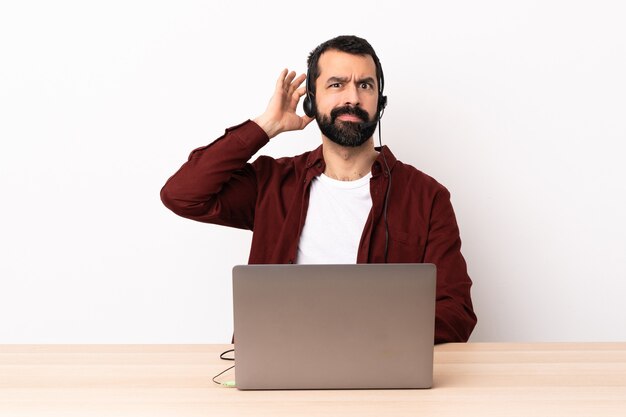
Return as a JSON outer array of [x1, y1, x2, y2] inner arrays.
[[302, 56, 391, 263]]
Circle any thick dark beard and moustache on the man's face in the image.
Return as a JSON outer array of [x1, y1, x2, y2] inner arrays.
[[315, 106, 378, 148]]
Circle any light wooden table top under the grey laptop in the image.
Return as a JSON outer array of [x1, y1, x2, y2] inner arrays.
[[0, 343, 626, 417]]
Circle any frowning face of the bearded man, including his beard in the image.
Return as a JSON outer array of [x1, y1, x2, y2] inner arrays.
[[315, 50, 378, 147]]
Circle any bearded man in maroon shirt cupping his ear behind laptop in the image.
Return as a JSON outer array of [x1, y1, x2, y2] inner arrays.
[[161, 36, 476, 343]]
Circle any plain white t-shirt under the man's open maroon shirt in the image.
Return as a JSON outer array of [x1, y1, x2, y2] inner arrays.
[[296, 173, 372, 264]]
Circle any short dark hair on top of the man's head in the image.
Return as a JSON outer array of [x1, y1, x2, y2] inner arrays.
[[307, 35, 383, 95]]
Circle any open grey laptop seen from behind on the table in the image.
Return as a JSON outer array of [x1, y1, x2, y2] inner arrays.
[[233, 264, 436, 390]]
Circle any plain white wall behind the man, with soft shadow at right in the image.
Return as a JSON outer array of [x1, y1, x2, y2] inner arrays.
[[0, 0, 626, 343]]
